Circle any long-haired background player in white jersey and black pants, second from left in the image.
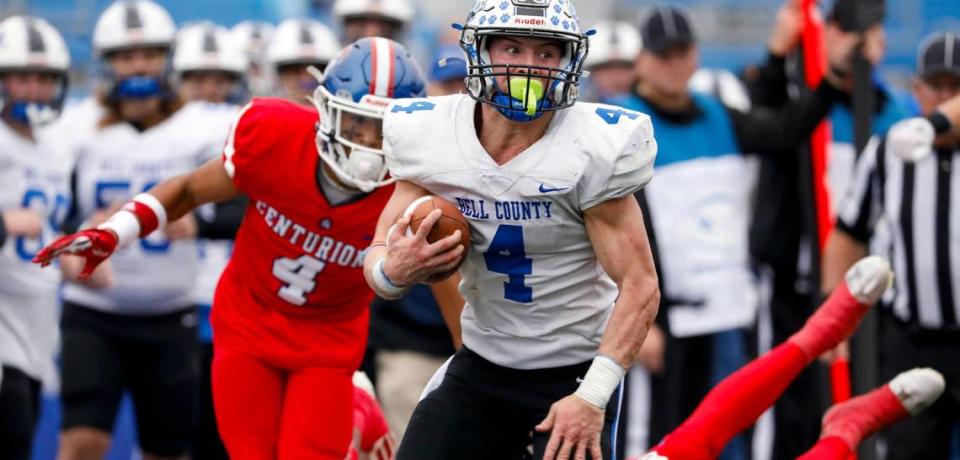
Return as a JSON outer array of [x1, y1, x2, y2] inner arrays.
[[54, 0, 235, 459]]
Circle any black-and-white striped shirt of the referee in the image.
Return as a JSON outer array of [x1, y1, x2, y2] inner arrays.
[[837, 138, 960, 330]]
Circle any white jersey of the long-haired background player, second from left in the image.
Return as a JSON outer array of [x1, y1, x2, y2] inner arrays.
[[64, 102, 236, 315]]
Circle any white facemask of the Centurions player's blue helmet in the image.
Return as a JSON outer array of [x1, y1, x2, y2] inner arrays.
[[313, 78, 394, 193]]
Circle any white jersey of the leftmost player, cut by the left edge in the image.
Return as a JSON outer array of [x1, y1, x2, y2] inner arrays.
[[0, 121, 73, 380]]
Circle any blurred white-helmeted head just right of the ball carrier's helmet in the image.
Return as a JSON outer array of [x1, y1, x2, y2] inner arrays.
[[584, 21, 640, 102]]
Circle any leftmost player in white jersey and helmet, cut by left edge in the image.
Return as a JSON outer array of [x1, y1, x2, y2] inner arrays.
[[0, 16, 71, 459]]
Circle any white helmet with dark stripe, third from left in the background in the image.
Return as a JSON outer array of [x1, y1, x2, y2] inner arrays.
[[173, 22, 247, 77]]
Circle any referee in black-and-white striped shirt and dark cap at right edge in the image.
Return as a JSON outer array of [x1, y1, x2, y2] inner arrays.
[[823, 33, 960, 460]]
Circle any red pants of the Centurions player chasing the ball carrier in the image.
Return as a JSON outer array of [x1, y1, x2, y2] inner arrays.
[[212, 348, 353, 460]]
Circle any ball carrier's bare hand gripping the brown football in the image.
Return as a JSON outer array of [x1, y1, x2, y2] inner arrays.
[[383, 209, 464, 286]]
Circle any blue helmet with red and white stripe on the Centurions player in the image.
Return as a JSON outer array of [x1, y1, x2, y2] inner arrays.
[[313, 37, 426, 192]]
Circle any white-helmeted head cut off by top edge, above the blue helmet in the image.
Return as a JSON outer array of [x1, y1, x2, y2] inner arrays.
[[333, 0, 414, 42]]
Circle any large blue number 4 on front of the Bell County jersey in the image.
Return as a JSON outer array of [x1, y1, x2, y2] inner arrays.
[[483, 225, 533, 303]]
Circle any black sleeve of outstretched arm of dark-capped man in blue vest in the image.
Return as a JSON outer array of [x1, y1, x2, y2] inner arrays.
[[728, 79, 842, 155]]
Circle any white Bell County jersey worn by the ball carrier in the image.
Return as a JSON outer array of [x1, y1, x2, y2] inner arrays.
[[383, 95, 657, 369]]
